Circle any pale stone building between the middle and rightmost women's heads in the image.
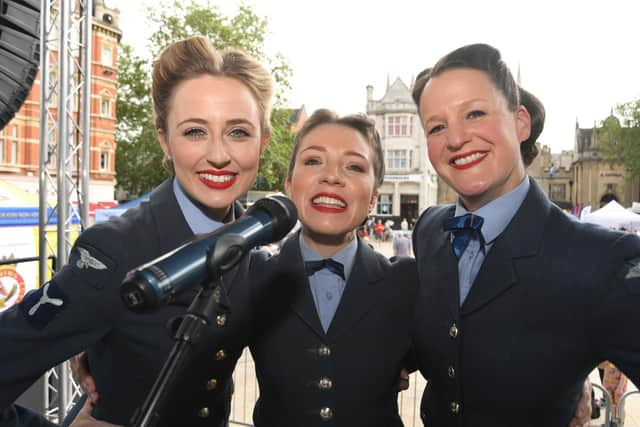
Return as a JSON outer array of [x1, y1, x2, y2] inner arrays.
[[366, 78, 438, 225]]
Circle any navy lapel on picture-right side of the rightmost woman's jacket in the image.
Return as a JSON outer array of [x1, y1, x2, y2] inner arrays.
[[461, 179, 551, 314]]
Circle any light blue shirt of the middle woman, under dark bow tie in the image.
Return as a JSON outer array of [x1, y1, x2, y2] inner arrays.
[[299, 233, 358, 332]]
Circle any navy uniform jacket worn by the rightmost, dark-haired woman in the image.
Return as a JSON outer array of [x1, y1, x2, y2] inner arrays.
[[413, 180, 640, 427]]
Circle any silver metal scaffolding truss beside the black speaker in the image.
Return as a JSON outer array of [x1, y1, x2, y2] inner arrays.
[[38, 0, 93, 421]]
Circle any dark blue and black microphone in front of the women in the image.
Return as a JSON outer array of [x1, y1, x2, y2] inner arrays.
[[120, 195, 298, 312]]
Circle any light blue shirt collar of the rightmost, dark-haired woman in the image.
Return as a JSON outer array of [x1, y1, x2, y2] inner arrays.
[[455, 176, 530, 244]]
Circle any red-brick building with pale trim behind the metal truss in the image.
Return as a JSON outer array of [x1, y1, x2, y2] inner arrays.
[[0, 0, 122, 202]]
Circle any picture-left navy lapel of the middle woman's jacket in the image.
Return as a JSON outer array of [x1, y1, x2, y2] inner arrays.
[[278, 231, 325, 337]]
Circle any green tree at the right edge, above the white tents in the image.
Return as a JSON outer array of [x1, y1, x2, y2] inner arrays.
[[598, 99, 640, 178]]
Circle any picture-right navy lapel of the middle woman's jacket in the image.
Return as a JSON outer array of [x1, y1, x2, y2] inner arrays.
[[327, 239, 388, 341]]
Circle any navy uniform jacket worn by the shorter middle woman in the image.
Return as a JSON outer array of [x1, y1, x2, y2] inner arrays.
[[209, 233, 417, 427]]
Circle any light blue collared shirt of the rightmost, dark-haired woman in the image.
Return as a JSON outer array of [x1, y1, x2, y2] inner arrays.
[[455, 176, 530, 305]]
